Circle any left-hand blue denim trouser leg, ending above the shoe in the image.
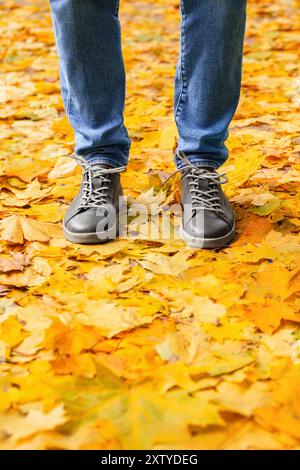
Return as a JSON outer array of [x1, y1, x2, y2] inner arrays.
[[50, 0, 130, 167]]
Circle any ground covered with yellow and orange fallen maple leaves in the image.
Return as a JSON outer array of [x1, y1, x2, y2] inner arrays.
[[0, 0, 300, 449]]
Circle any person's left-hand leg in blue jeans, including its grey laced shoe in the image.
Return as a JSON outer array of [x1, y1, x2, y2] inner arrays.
[[50, 0, 130, 243]]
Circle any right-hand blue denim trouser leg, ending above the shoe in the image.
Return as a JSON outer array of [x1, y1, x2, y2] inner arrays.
[[175, 0, 246, 168]]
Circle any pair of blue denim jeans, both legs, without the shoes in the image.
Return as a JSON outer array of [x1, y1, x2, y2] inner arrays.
[[50, 0, 246, 168]]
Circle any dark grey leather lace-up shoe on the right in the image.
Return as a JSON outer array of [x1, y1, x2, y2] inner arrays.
[[180, 155, 235, 248]]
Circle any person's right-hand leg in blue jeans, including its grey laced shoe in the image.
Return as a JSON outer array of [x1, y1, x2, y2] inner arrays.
[[175, 0, 246, 248]]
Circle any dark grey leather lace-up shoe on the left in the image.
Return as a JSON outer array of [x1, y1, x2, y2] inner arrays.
[[63, 157, 125, 244]]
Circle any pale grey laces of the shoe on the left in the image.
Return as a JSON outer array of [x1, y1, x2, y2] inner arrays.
[[71, 154, 126, 209]]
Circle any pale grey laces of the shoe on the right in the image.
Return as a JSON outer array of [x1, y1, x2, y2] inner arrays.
[[164, 150, 228, 213]]
